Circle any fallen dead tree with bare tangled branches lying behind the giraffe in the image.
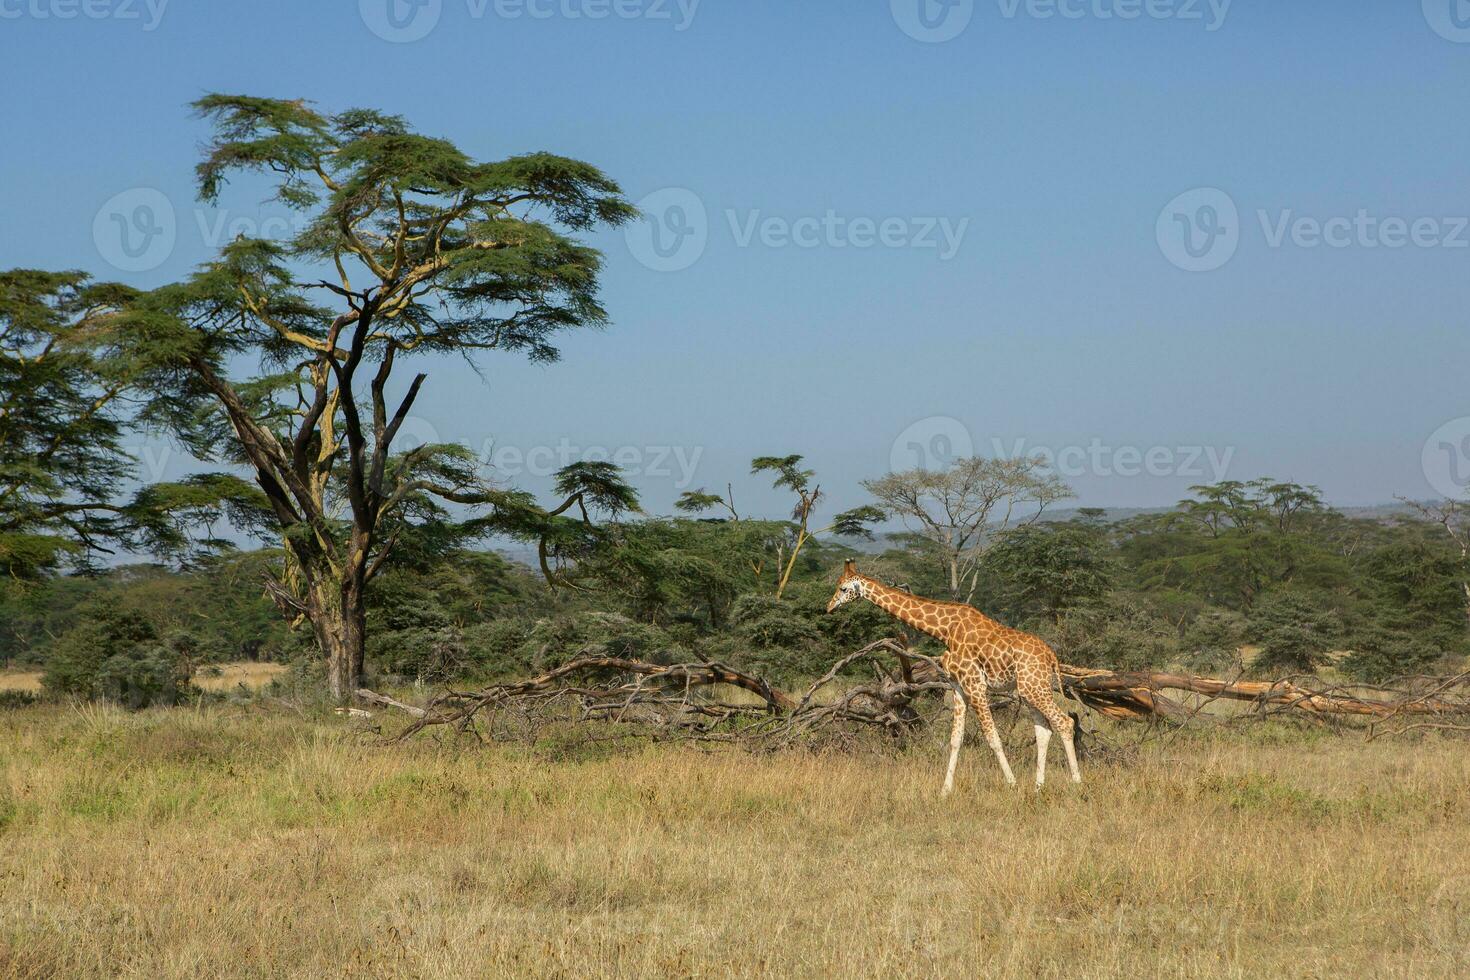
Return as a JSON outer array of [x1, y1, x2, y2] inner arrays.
[[357, 639, 1470, 743]]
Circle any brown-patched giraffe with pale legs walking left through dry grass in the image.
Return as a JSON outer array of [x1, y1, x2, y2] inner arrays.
[[828, 560, 1082, 796]]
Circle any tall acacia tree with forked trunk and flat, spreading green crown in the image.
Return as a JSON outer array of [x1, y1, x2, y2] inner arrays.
[[106, 96, 635, 698]]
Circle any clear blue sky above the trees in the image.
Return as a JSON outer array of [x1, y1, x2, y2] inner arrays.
[[0, 0, 1470, 525]]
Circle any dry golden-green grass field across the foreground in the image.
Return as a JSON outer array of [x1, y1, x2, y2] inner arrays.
[[0, 704, 1470, 977]]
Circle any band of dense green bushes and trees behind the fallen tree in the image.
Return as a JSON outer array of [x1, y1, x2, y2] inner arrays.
[[0, 485, 1470, 688]]
